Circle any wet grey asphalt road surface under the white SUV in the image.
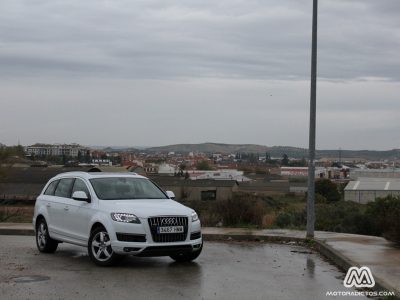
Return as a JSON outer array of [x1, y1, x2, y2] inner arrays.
[[0, 236, 363, 300]]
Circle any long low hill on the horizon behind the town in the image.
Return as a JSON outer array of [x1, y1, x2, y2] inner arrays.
[[146, 143, 400, 160]]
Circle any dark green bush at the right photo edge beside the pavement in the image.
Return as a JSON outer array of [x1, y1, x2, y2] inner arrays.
[[366, 196, 400, 243]]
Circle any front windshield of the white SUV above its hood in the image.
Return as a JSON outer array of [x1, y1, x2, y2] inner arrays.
[[90, 177, 168, 200]]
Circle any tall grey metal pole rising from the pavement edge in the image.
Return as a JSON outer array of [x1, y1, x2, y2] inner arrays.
[[307, 0, 318, 238]]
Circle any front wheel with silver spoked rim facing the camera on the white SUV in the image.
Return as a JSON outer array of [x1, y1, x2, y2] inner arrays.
[[88, 227, 119, 267]]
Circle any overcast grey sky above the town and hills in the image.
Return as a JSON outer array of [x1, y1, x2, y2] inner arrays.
[[0, 0, 400, 149]]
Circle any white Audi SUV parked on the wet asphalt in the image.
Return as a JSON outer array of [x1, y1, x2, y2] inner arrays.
[[33, 172, 203, 266]]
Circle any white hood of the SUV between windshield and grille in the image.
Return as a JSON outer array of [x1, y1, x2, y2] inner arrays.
[[100, 199, 193, 218]]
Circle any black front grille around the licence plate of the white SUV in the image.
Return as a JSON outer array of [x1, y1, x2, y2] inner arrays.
[[148, 216, 188, 243]]
